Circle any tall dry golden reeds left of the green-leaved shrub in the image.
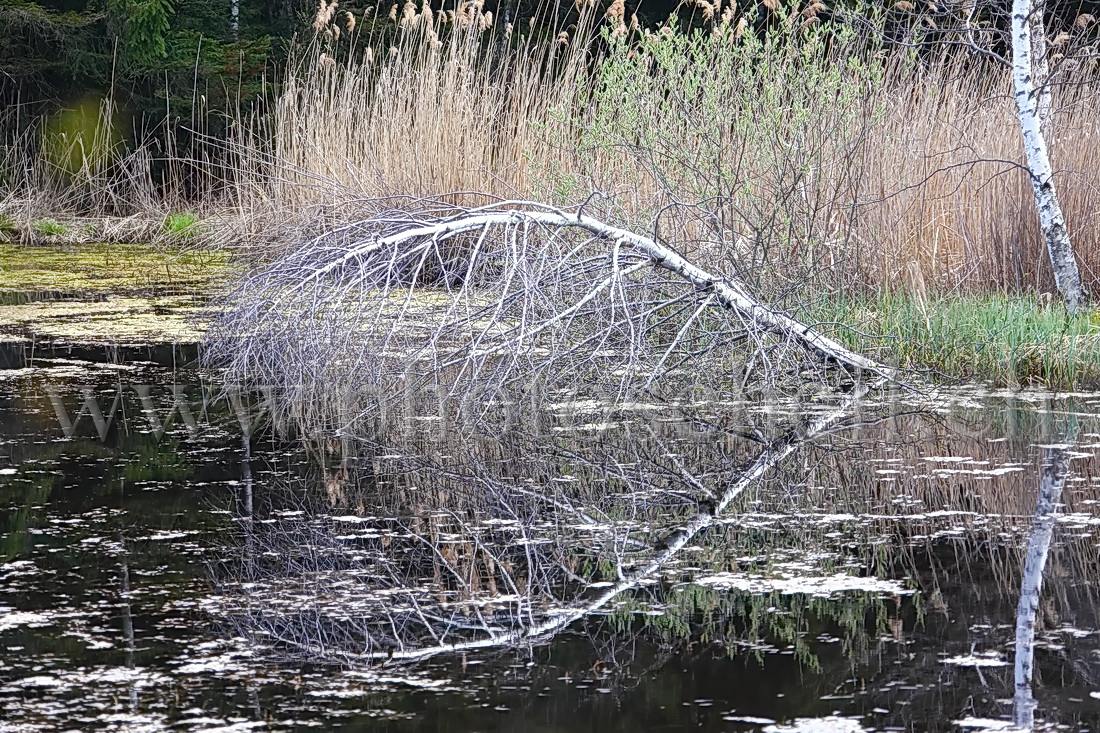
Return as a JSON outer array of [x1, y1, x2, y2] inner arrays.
[[227, 1, 592, 219]]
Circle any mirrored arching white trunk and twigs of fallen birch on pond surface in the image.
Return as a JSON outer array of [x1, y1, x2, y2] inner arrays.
[[216, 382, 881, 664]]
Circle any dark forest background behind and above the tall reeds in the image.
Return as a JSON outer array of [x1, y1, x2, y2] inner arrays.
[[0, 0, 1100, 148]]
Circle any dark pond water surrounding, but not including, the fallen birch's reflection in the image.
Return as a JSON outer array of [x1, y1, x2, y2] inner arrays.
[[0, 350, 1100, 731]]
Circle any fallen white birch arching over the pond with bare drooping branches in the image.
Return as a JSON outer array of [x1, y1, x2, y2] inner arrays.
[[207, 201, 898, 427]]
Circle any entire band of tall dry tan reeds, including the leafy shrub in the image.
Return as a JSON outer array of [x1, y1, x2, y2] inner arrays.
[[227, 2, 1100, 298]]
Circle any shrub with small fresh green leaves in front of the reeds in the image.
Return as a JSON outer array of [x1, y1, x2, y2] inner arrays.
[[556, 17, 887, 294]]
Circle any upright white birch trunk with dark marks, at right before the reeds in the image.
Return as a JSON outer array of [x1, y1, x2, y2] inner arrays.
[[1012, 0, 1089, 313]]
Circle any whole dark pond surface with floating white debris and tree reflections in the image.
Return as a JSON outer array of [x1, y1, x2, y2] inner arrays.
[[0, 350, 1100, 731]]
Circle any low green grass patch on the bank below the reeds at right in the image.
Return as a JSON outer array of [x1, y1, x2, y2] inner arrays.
[[800, 294, 1100, 390]]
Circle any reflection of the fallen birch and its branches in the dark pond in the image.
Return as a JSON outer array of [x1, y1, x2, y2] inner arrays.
[[214, 386, 884, 661]]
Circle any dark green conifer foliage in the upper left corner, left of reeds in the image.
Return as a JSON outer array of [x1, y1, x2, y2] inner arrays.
[[0, 0, 292, 183]]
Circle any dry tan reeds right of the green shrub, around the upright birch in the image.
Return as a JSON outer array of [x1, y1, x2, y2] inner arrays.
[[855, 62, 1100, 292]]
